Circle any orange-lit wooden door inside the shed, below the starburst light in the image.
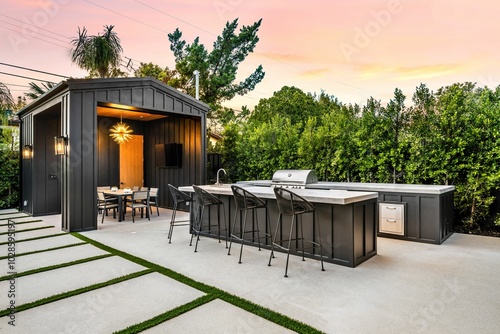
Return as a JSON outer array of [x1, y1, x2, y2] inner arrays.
[[120, 135, 144, 189]]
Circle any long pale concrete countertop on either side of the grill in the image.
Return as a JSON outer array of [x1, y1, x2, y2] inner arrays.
[[238, 180, 455, 194]]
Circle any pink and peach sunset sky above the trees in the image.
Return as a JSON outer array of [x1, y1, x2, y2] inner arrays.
[[0, 0, 500, 109]]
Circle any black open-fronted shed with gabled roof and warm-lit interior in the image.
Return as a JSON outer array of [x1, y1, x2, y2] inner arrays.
[[18, 78, 209, 232]]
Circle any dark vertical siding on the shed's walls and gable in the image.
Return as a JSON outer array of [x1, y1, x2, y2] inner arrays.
[[20, 78, 208, 231]]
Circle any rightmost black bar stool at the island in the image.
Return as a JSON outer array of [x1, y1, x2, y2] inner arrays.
[[268, 187, 325, 277]]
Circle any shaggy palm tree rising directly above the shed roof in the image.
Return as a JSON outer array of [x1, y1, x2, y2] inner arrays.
[[71, 25, 123, 78]]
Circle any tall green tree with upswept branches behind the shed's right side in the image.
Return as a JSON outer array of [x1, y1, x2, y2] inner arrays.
[[168, 19, 265, 110]]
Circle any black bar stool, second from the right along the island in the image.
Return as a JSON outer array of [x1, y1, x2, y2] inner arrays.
[[227, 185, 271, 263]]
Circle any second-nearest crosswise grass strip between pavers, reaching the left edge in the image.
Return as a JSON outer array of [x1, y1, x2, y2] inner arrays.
[[0, 269, 154, 317]]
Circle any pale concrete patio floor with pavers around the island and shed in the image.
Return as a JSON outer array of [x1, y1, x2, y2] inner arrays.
[[0, 209, 500, 334]]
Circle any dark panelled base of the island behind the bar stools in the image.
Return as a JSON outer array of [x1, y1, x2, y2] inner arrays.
[[191, 195, 377, 268]]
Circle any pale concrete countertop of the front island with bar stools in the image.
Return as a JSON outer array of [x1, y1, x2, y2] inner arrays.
[[179, 183, 378, 205]]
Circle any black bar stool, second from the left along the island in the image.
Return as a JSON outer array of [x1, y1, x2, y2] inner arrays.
[[189, 185, 227, 252]]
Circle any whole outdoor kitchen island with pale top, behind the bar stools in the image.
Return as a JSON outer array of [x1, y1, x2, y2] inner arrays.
[[179, 183, 378, 267]]
